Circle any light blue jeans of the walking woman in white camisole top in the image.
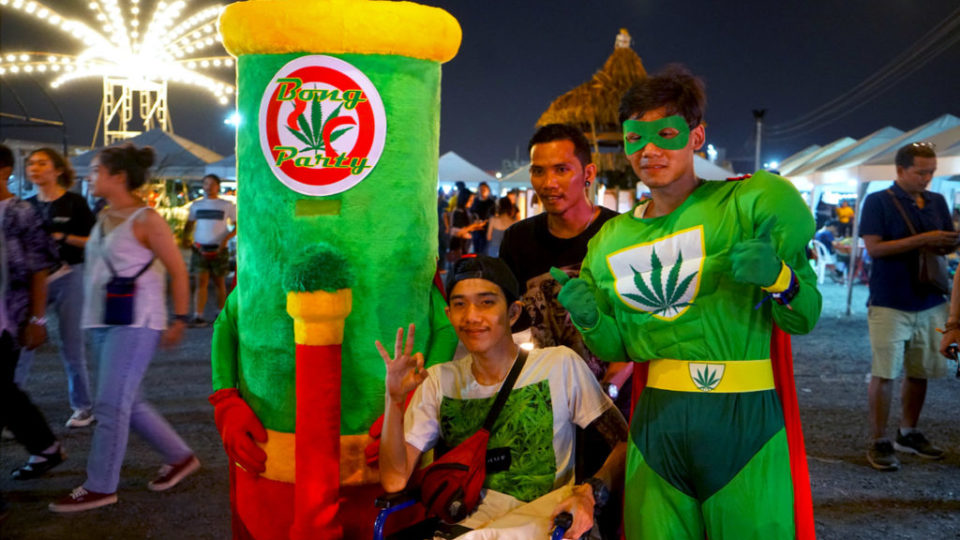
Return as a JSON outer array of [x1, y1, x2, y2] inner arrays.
[[83, 326, 193, 493]]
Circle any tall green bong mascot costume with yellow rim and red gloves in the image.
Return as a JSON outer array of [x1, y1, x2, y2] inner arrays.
[[211, 0, 461, 540]]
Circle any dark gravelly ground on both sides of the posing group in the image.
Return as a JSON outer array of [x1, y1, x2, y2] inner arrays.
[[0, 284, 960, 540]]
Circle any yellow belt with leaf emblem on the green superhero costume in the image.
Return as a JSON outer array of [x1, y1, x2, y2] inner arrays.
[[647, 359, 774, 393]]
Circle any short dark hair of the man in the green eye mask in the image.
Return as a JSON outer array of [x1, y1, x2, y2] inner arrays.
[[619, 64, 707, 129]]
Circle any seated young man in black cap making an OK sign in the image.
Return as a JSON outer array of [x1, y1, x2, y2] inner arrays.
[[376, 256, 627, 538]]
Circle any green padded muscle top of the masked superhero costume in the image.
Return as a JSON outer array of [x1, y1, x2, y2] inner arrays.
[[580, 172, 821, 361]]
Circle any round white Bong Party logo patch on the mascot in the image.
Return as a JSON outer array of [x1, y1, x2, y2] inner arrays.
[[260, 55, 387, 195]]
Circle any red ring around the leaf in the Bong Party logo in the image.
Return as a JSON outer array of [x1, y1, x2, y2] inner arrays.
[[266, 66, 376, 186]]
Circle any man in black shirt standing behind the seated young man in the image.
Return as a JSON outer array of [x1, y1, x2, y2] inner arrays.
[[500, 124, 617, 379]]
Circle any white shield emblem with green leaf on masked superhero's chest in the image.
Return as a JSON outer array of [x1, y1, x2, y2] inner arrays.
[[607, 226, 704, 321]]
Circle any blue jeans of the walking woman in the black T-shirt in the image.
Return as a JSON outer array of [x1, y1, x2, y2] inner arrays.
[[13, 264, 93, 410]]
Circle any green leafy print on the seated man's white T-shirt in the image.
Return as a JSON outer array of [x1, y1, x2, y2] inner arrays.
[[440, 380, 557, 502]]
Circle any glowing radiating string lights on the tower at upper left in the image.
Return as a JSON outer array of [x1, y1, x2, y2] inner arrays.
[[0, 0, 236, 144]]
